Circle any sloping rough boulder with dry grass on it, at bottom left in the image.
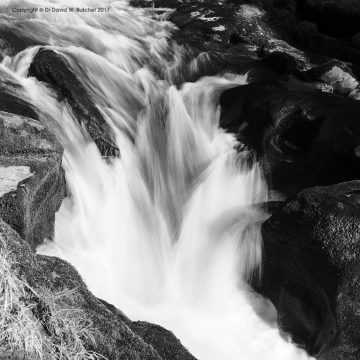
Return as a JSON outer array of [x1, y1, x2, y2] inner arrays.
[[0, 220, 195, 360]]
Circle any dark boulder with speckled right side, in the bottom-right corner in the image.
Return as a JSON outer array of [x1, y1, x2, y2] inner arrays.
[[255, 181, 360, 360]]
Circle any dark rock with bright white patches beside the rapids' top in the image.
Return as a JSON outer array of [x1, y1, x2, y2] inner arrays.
[[169, 1, 317, 81]]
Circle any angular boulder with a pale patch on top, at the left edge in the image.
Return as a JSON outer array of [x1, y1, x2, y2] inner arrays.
[[0, 153, 66, 249]]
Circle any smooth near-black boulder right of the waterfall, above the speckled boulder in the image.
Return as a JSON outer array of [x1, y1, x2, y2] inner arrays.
[[220, 82, 360, 195]]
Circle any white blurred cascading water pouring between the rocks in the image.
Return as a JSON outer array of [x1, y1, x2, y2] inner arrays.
[[1, 0, 314, 360]]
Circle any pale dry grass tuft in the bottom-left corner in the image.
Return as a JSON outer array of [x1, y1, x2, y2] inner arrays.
[[0, 249, 105, 360]]
